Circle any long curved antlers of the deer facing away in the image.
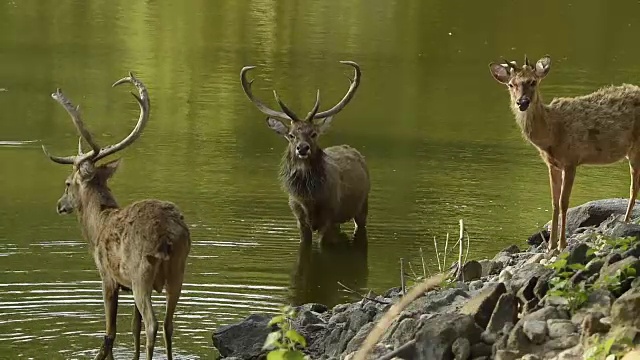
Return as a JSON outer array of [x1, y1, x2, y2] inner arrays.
[[42, 72, 151, 164]]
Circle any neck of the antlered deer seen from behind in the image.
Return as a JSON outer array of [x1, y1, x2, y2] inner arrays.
[[78, 185, 118, 247]]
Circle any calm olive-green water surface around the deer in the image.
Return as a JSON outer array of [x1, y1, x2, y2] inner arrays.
[[0, 0, 640, 359]]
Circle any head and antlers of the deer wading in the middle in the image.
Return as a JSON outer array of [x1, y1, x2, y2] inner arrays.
[[240, 61, 360, 160]]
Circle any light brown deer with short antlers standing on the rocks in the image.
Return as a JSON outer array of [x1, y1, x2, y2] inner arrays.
[[489, 56, 640, 251]]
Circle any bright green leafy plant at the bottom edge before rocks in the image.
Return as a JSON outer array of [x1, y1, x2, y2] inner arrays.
[[262, 306, 310, 360]]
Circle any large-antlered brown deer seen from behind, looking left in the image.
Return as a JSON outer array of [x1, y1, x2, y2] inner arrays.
[[42, 73, 191, 360]]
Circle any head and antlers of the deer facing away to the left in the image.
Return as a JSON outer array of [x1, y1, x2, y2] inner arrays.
[[42, 73, 150, 214]]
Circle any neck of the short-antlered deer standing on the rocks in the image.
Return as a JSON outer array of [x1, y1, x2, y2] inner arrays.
[[511, 95, 551, 148]]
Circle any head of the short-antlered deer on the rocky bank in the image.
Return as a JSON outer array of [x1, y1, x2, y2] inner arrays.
[[489, 55, 551, 111]]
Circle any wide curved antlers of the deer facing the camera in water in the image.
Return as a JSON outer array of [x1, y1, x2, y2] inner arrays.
[[240, 61, 361, 122]]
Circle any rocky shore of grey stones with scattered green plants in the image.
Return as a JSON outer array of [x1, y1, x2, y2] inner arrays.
[[213, 199, 640, 360]]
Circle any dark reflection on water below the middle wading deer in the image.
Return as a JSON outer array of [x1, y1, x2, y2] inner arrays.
[[289, 230, 369, 307]]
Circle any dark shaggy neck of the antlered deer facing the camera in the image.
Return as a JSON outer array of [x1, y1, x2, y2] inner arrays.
[[280, 149, 327, 200]]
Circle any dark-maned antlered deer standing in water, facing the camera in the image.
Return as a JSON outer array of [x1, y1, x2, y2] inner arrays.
[[240, 61, 370, 243]]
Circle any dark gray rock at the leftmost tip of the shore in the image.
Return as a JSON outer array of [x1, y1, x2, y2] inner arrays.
[[212, 314, 276, 359]]
